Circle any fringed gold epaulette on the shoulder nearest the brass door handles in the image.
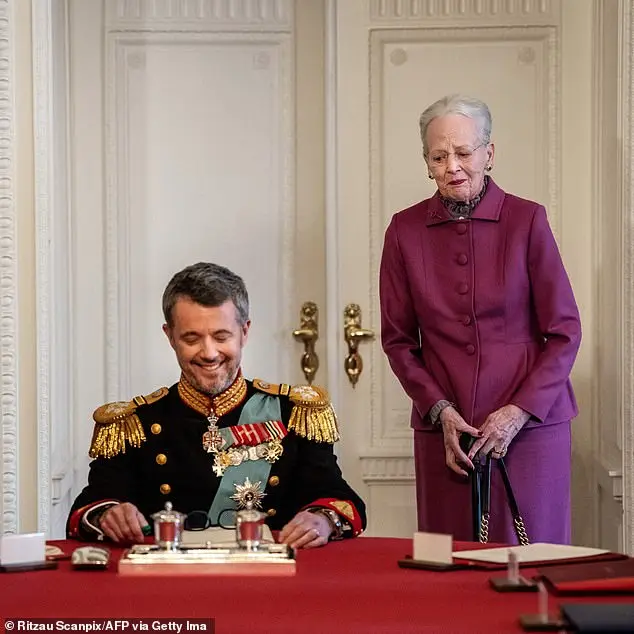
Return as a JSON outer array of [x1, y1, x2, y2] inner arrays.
[[288, 385, 339, 443]]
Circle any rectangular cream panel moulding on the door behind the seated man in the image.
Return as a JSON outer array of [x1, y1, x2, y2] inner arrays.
[[104, 31, 295, 400]]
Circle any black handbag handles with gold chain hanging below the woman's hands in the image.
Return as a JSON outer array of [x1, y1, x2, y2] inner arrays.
[[460, 434, 530, 546]]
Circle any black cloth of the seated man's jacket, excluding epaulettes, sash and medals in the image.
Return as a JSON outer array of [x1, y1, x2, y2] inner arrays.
[[67, 381, 366, 539]]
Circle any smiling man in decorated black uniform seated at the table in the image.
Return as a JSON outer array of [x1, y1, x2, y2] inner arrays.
[[67, 263, 366, 548]]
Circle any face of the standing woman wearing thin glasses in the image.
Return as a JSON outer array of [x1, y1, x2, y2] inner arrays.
[[425, 114, 495, 202]]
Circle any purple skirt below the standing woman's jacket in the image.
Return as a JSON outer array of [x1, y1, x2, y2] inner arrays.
[[414, 422, 571, 544]]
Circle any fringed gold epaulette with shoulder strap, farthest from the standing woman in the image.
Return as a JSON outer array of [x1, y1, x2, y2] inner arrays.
[[88, 387, 169, 458]]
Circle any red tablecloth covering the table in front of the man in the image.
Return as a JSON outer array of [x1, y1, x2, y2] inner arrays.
[[0, 537, 631, 634]]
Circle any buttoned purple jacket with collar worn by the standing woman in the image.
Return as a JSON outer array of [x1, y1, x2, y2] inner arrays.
[[380, 180, 581, 429]]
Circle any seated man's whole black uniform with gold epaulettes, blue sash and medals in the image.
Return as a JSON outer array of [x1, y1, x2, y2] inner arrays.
[[67, 373, 366, 539]]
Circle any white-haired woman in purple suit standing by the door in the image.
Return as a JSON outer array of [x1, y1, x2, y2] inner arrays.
[[380, 95, 581, 543]]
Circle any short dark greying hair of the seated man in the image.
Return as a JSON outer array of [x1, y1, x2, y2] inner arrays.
[[163, 262, 249, 328]]
